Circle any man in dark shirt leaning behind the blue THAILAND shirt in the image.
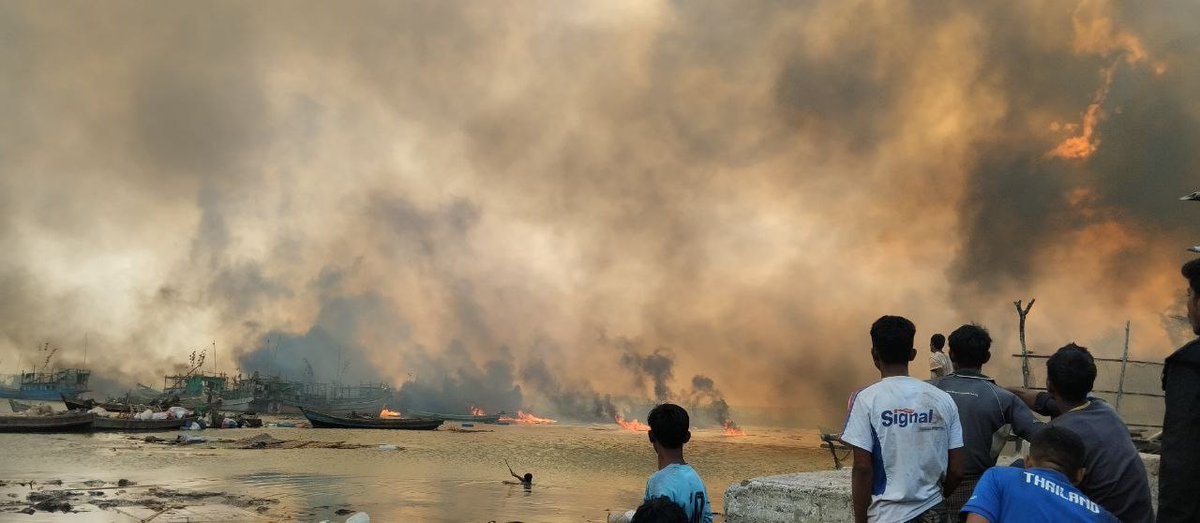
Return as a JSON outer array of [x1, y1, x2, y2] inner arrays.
[[1024, 343, 1152, 523]]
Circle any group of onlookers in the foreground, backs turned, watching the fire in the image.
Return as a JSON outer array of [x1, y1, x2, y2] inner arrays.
[[632, 259, 1200, 523]]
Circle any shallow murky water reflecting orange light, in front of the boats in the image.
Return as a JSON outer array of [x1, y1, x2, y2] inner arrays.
[[0, 425, 832, 522]]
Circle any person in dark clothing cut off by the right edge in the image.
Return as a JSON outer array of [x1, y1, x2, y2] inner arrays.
[[1158, 257, 1200, 523]]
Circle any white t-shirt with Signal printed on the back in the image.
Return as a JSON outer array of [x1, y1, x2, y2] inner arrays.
[[841, 375, 962, 522]]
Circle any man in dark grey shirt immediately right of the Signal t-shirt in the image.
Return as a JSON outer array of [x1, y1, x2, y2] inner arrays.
[[932, 325, 1044, 521]]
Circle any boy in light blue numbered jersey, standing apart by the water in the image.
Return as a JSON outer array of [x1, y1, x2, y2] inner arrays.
[[643, 403, 713, 523]]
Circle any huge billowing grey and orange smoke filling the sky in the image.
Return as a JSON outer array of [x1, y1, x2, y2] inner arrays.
[[0, 0, 1200, 423]]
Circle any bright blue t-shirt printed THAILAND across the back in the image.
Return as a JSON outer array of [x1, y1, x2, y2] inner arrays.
[[962, 467, 1117, 523]]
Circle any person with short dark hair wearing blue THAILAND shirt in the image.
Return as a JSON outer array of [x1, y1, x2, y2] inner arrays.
[[962, 426, 1117, 523]]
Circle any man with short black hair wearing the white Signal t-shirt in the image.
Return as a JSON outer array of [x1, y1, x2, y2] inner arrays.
[[841, 315, 962, 523]]
